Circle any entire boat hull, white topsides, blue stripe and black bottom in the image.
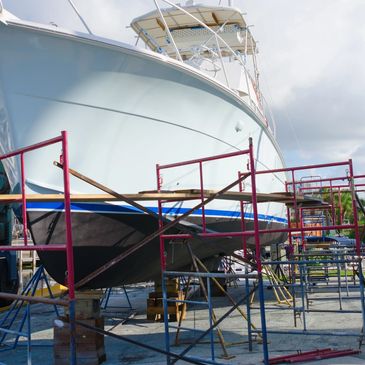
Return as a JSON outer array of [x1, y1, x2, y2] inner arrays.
[[0, 22, 286, 287]]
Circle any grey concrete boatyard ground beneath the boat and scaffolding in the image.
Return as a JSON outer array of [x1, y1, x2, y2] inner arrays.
[[0, 278, 365, 365]]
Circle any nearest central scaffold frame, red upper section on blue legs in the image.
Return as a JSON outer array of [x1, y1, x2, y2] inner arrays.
[[156, 138, 269, 365]]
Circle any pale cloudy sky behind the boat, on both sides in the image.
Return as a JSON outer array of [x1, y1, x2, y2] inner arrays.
[[3, 0, 365, 179]]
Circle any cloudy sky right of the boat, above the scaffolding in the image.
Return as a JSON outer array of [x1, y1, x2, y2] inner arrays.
[[237, 0, 365, 172]]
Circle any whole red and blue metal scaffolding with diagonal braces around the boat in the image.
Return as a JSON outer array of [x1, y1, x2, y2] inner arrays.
[[0, 131, 365, 365]]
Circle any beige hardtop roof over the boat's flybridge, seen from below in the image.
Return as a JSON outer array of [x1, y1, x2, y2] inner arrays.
[[131, 5, 256, 58]]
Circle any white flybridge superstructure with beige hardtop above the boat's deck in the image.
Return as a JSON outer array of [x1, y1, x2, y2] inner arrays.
[[131, 0, 275, 129]]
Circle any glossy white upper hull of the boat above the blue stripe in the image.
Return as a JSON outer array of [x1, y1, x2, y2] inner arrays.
[[0, 19, 285, 221]]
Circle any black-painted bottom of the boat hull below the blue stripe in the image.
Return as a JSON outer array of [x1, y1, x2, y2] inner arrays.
[[28, 211, 286, 289]]
